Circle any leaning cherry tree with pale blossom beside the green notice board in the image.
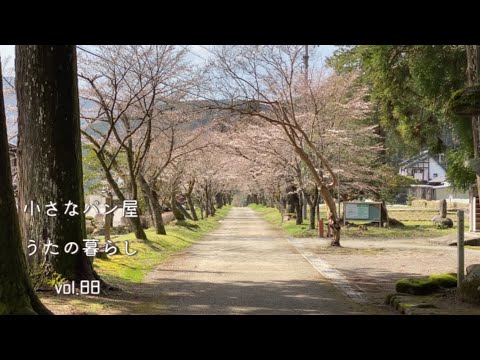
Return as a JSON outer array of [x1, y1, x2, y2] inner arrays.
[[212, 46, 375, 246]]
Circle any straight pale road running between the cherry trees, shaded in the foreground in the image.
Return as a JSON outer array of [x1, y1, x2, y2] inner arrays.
[[145, 208, 360, 314]]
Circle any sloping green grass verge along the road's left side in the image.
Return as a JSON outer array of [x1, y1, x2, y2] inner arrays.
[[93, 206, 231, 284]]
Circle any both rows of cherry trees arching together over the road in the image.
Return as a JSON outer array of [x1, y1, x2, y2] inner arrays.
[[79, 45, 380, 245]]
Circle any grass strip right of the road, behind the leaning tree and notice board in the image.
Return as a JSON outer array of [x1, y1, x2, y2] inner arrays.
[[248, 204, 457, 239]]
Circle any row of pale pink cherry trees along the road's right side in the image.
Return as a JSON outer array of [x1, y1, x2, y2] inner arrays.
[[211, 46, 381, 246]]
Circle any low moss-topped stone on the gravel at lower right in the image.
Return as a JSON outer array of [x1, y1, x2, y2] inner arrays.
[[395, 273, 457, 295]]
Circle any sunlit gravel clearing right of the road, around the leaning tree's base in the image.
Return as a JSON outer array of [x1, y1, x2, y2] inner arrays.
[[295, 238, 480, 313]]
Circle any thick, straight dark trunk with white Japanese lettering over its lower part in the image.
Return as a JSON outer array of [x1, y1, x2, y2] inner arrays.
[[15, 45, 102, 280]]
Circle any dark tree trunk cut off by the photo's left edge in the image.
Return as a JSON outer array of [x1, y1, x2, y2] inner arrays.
[[0, 62, 51, 315]]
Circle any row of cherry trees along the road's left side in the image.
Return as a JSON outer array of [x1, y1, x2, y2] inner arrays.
[[79, 45, 236, 240]]
